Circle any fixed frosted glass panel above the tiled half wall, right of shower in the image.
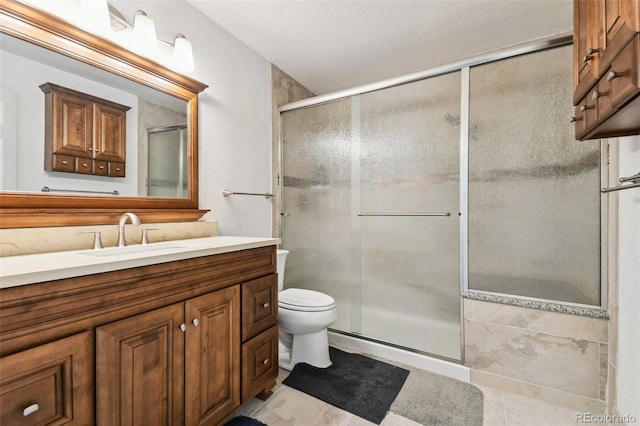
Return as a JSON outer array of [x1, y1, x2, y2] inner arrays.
[[469, 46, 600, 305]]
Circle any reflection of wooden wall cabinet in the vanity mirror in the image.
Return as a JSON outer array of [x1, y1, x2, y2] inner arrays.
[[40, 83, 130, 177]]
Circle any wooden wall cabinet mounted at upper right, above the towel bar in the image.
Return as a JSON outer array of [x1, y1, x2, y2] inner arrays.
[[573, 0, 640, 140]]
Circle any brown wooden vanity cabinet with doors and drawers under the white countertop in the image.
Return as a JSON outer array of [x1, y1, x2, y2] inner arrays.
[[0, 246, 278, 426]]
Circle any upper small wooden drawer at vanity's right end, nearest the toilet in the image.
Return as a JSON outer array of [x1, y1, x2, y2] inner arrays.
[[242, 274, 278, 342]]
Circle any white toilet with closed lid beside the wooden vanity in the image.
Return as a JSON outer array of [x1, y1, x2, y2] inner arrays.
[[277, 250, 338, 370]]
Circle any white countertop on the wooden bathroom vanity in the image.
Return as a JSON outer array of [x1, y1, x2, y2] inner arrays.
[[0, 236, 280, 288]]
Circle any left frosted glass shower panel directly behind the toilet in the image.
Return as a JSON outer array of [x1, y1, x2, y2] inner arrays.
[[282, 100, 359, 332]]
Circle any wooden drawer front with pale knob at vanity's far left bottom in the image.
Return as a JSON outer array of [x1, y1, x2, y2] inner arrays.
[[0, 332, 94, 426]]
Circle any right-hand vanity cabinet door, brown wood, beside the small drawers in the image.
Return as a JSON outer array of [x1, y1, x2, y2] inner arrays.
[[185, 285, 240, 426]]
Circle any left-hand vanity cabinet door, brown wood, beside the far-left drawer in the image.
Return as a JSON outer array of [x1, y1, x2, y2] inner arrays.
[[96, 303, 184, 426]]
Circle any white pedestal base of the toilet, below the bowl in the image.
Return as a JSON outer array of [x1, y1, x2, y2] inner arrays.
[[278, 328, 331, 371]]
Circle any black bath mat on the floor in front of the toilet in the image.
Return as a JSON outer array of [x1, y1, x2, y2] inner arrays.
[[282, 347, 409, 424]]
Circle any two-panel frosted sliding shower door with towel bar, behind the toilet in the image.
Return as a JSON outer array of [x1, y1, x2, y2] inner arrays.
[[282, 72, 461, 360]]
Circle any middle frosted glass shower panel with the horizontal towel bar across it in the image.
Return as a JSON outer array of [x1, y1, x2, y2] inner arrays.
[[359, 73, 460, 359]]
